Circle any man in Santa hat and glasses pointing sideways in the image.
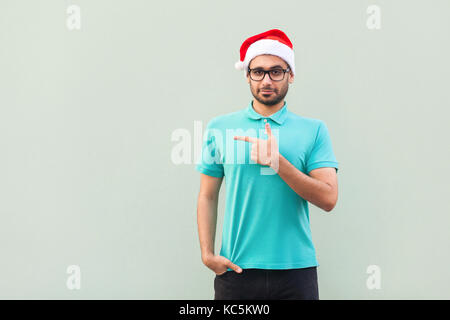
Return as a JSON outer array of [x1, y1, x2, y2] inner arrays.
[[196, 29, 338, 300]]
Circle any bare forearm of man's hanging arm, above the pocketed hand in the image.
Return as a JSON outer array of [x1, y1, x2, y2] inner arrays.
[[197, 195, 218, 260]]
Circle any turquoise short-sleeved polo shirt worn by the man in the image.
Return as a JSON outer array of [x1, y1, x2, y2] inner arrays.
[[195, 102, 338, 270]]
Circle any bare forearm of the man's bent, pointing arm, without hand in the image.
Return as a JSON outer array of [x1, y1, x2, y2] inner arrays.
[[277, 155, 332, 211]]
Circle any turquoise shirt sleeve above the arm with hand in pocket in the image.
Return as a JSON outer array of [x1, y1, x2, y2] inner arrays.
[[195, 122, 225, 178]]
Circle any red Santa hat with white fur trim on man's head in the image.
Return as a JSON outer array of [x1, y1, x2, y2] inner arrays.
[[234, 29, 295, 75]]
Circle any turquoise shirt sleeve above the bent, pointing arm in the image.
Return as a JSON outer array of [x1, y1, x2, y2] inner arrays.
[[306, 121, 338, 173]]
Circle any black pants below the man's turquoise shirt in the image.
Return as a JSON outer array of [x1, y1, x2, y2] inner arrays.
[[214, 267, 319, 300]]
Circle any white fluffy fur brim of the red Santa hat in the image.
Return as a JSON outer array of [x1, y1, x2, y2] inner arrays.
[[243, 39, 295, 75]]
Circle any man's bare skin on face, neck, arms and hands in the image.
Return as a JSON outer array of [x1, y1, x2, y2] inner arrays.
[[197, 55, 338, 275]]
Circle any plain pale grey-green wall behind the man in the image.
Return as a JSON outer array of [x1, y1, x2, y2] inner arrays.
[[0, 0, 450, 299]]
